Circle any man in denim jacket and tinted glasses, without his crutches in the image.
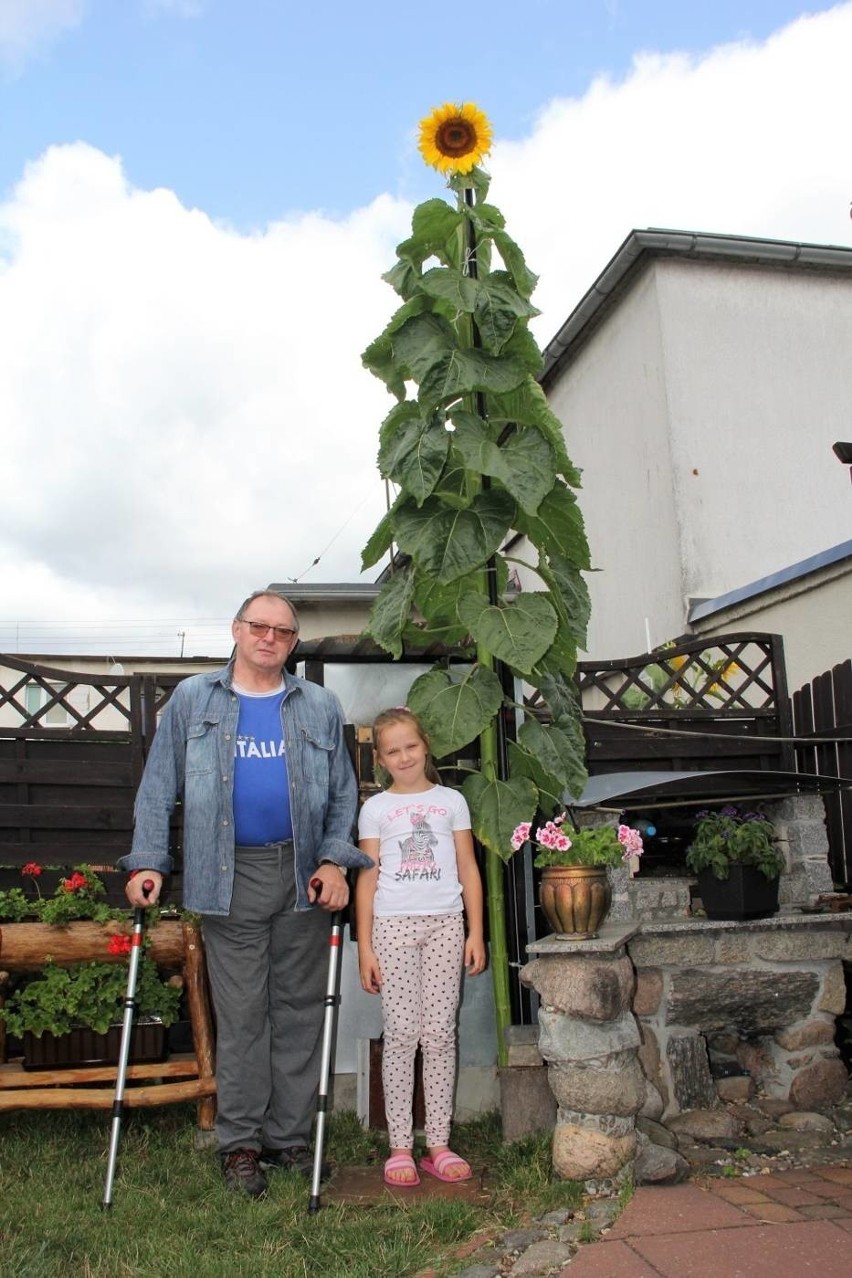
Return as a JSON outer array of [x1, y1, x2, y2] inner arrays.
[[119, 590, 372, 1197]]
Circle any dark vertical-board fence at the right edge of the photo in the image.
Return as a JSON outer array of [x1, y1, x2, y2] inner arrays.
[[791, 661, 852, 891]]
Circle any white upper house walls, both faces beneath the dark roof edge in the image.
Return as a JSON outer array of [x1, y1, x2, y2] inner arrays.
[[548, 257, 852, 659]]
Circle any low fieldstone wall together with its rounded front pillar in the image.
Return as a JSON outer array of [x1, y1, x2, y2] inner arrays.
[[521, 911, 852, 1180]]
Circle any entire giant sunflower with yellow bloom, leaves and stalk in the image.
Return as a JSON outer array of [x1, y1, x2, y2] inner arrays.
[[363, 104, 590, 1063]]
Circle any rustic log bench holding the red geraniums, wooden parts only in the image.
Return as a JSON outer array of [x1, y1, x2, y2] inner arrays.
[[0, 919, 216, 1131]]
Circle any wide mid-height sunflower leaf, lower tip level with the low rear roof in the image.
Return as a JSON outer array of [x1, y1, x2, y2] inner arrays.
[[395, 489, 516, 583]]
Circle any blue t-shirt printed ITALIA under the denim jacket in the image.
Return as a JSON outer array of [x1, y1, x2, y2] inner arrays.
[[234, 689, 293, 847]]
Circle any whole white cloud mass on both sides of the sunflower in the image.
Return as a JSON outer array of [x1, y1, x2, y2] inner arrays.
[[0, 4, 852, 649]]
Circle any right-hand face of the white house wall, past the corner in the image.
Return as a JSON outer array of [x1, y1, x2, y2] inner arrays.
[[654, 259, 852, 598]]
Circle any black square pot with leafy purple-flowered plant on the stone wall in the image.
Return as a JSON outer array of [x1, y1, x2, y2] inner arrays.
[[686, 804, 784, 920]]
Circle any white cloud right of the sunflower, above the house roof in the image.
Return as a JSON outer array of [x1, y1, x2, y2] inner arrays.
[[491, 4, 852, 341]]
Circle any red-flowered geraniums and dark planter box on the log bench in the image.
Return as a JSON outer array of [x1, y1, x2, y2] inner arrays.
[[0, 863, 183, 1068]]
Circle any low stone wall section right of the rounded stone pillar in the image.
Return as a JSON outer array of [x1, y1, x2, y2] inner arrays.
[[627, 914, 852, 1120]]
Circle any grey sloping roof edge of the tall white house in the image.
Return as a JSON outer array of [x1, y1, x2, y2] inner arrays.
[[540, 227, 852, 390]]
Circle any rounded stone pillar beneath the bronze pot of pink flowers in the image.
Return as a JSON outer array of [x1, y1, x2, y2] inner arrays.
[[521, 923, 645, 1180]]
